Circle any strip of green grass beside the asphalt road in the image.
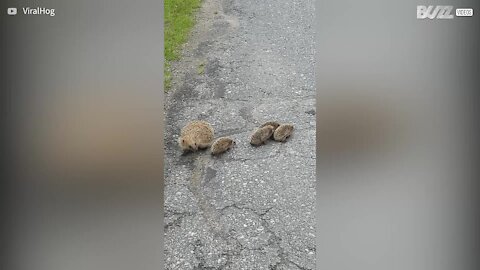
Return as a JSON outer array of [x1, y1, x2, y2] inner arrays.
[[164, 0, 202, 89]]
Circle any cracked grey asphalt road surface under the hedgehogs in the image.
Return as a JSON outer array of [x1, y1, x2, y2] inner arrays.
[[165, 0, 316, 270]]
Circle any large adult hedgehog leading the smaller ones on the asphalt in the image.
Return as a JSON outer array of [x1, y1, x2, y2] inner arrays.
[[178, 120, 214, 151]]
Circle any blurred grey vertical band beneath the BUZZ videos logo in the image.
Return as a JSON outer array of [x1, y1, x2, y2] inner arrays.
[[316, 0, 480, 270]]
